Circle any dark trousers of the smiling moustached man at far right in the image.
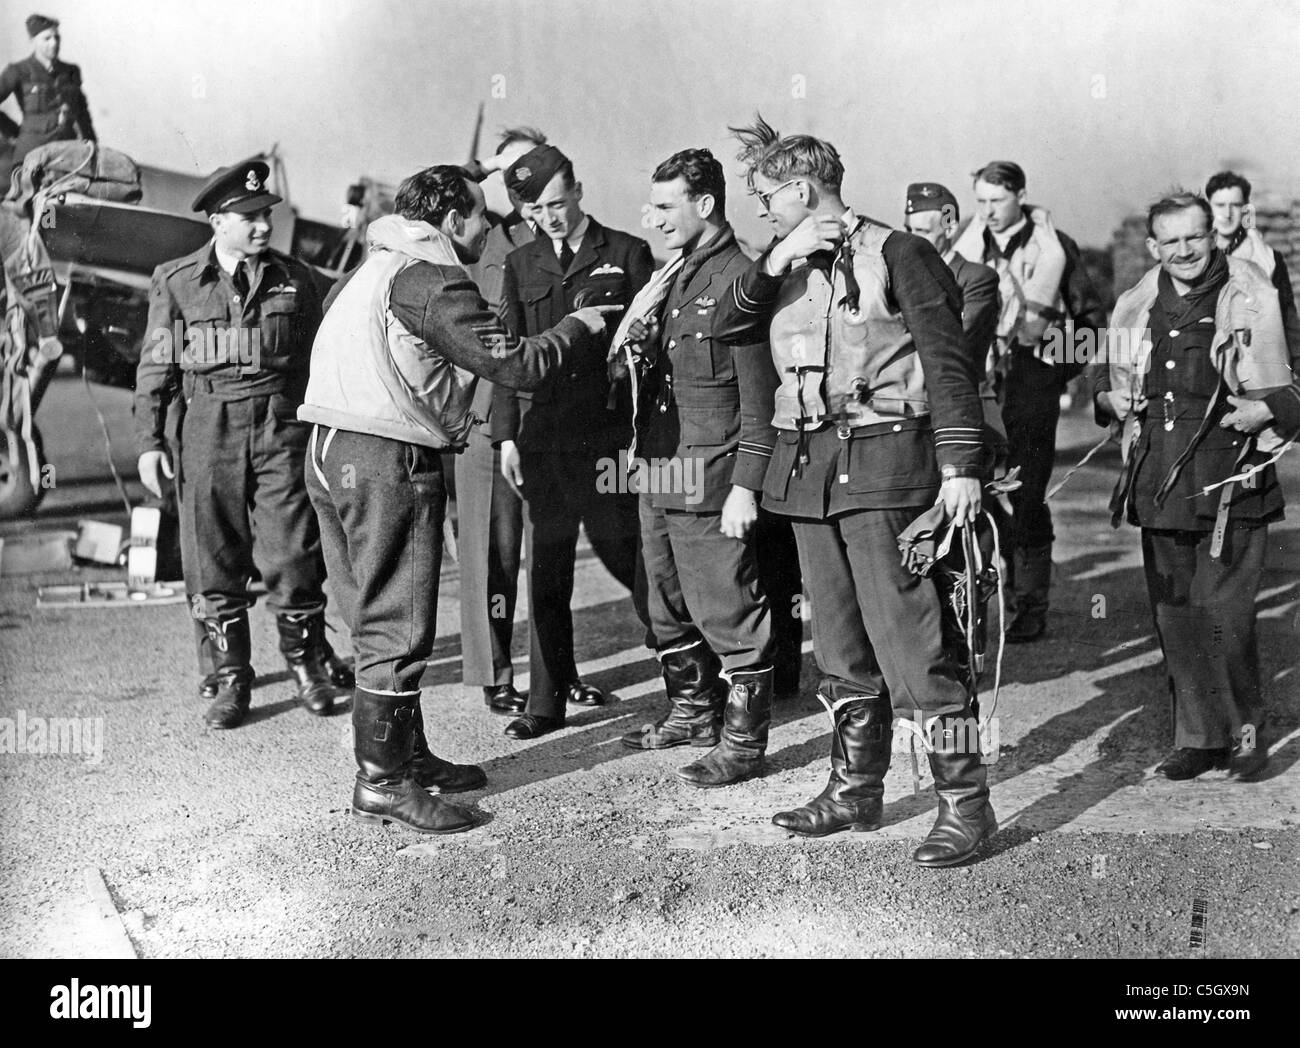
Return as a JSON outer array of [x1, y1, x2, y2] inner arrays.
[[1141, 527, 1269, 749]]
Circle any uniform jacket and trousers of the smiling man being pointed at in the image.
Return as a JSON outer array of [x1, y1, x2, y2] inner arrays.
[[637, 226, 774, 680]]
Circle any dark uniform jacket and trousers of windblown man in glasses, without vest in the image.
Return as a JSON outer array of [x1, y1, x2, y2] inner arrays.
[[719, 231, 984, 716]]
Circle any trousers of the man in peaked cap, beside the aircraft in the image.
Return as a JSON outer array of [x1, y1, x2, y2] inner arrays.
[[181, 392, 325, 622]]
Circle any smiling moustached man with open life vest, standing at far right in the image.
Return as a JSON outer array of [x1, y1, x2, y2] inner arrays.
[[1093, 192, 1300, 780]]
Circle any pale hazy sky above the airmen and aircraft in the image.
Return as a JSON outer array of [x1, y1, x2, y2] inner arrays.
[[0, 0, 1300, 252]]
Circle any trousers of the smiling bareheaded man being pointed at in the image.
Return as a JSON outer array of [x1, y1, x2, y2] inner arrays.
[[641, 495, 771, 674]]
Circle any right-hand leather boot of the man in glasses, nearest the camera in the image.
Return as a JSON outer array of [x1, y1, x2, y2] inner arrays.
[[911, 711, 997, 867]]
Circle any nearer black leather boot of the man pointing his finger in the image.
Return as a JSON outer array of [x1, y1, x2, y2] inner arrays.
[[352, 688, 475, 833]]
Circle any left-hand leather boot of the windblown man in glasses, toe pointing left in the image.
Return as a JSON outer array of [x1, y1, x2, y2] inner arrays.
[[772, 692, 893, 837]]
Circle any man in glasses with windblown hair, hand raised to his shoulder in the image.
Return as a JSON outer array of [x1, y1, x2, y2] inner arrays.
[[718, 118, 996, 866]]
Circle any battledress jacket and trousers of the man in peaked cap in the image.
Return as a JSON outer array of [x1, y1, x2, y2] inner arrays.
[[135, 242, 325, 620]]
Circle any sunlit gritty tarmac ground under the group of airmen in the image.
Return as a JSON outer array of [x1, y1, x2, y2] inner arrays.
[[0, 377, 1300, 957]]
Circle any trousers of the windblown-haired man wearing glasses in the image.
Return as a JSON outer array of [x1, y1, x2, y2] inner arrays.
[[794, 507, 966, 719]]
